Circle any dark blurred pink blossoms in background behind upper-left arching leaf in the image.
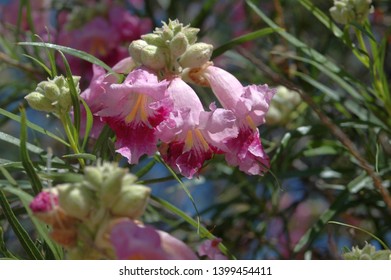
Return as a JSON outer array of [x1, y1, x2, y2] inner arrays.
[[57, 3, 152, 80]]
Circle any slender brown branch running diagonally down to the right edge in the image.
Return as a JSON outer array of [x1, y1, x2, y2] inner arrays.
[[238, 48, 391, 210]]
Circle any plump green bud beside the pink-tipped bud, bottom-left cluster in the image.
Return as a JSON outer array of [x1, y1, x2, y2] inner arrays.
[[56, 184, 94, 220]]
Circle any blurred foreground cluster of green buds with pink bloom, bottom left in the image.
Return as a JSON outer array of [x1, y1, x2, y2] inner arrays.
[[30, 163, 197, 259]]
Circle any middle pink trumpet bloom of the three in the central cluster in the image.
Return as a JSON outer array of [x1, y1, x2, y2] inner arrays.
[[157, 78, 237, 178]]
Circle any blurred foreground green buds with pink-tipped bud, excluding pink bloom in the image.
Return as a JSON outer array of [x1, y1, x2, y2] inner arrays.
[[30, 163, 150, 259]]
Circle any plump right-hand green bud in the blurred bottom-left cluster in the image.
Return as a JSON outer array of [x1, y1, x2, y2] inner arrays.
[[111, 185, 151, 219]]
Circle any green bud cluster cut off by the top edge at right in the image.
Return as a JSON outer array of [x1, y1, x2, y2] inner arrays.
[[330, 0, 373, 24]]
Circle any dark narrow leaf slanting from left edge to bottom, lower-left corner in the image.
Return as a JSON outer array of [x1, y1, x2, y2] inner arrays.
[[0, 190, 43, 260]]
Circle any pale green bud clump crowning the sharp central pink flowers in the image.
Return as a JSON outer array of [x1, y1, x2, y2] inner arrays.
[[129, 20, 213, 74]]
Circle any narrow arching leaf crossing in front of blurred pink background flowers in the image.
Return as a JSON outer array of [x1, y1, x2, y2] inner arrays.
[[18, 42, 121, 79]]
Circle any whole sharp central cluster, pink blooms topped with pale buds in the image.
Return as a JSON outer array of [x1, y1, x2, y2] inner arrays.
[[81, 20, 275, 178]]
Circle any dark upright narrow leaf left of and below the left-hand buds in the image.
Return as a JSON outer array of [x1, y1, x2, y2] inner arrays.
[[20, 107, 42, 194]]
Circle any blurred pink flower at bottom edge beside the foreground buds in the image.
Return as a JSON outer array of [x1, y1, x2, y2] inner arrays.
[[110, 220, 197, 260]]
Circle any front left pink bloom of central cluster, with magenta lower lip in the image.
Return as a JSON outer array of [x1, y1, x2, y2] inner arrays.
[[96, 69, 172, 164]]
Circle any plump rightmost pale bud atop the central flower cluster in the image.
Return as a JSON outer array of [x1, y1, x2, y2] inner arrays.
[[179, 43, 213, 68]]
